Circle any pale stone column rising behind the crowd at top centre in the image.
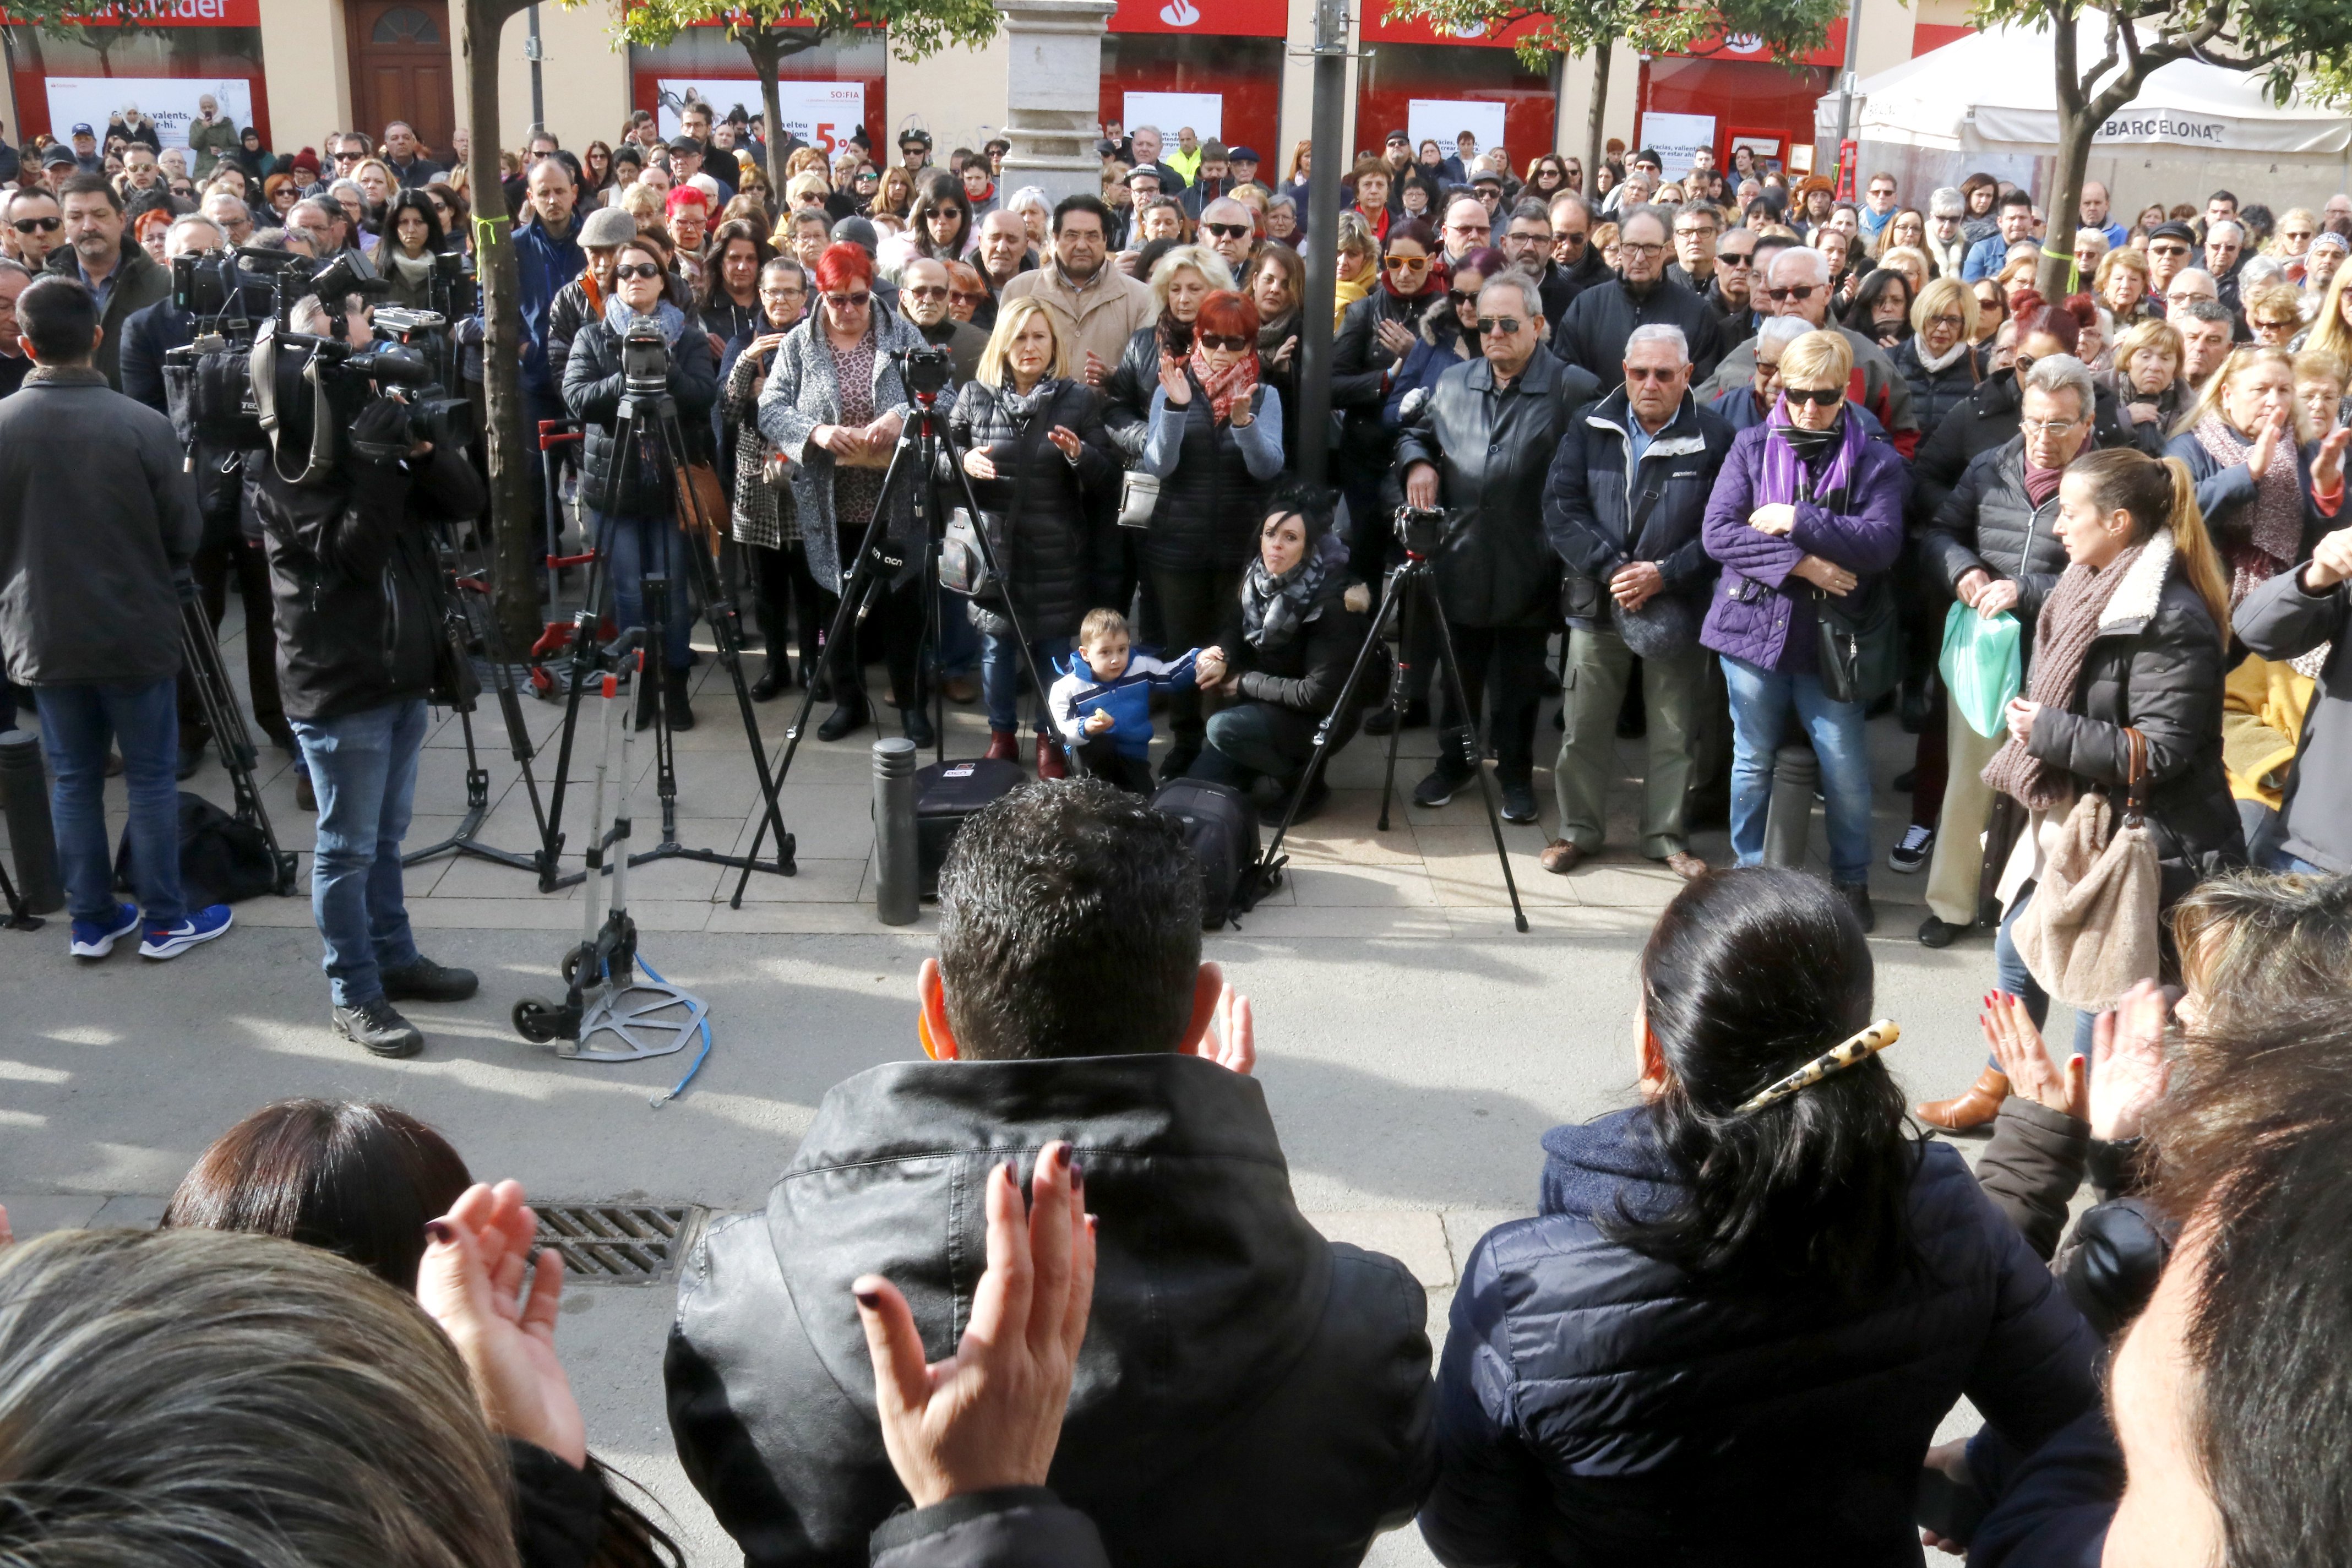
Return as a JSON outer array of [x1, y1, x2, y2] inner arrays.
[[997, 0, 1119, 202]]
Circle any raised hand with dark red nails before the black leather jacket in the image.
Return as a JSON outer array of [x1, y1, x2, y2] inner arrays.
[[849, 1142, 1093, 1507]]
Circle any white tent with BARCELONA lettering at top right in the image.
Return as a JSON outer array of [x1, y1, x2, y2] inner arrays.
[[1814, 17, 2352, 221]]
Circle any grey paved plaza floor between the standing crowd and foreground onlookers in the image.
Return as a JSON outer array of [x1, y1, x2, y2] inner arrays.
[[0, 606, 2063, 1566]]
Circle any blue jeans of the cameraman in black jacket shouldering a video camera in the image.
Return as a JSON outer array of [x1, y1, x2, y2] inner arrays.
[[294, 696, 426, 1006]]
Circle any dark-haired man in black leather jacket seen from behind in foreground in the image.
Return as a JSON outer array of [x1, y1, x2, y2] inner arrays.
[[663, 781, 1433, 1568]]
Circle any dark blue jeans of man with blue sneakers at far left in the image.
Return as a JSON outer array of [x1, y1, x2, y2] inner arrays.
[[33, 679, 188, 926]]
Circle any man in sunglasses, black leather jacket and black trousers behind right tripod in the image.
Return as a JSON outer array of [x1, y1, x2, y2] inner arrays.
[[1397, 273, 1599, 823]]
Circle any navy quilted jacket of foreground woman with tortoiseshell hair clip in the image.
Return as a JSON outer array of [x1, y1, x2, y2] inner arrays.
[[1420, 1109, 2098, 1568]]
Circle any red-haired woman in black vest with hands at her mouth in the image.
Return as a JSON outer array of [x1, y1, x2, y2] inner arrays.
[[1136, 289, 1284, 781]]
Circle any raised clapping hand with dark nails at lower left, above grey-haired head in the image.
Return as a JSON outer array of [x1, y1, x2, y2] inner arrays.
[[416, 1183, 588, 1469]]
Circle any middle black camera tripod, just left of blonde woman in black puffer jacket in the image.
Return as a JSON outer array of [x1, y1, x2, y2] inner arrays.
[[729, 360, 1084, 907]]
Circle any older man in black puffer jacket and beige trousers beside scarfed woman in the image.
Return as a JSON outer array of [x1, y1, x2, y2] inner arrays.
[[1919, 355, 2095, 948]]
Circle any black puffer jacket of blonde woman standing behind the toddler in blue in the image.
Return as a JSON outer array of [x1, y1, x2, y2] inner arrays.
[[939, 381, 1119, 639]]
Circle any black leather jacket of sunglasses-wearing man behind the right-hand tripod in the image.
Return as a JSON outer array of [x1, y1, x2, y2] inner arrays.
[[1397, 352, 1599, 625]]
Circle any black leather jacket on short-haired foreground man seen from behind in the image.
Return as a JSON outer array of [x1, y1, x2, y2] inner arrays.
[[663, 1053, 1433, 1568]]
